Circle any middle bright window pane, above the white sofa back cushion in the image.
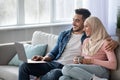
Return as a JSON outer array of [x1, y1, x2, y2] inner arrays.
[[25, 0, 50, 24]]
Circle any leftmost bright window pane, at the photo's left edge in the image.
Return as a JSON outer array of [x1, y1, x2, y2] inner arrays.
[[0, 0, 17, 26]]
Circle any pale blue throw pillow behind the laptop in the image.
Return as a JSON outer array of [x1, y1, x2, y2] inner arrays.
[[8, 44, 47, 66]]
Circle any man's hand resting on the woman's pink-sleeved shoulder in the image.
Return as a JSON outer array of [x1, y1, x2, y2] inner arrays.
[[105, 38, 118, 51]]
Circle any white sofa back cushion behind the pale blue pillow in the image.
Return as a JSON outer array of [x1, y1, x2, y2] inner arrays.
[[32, 31, 58, 52]]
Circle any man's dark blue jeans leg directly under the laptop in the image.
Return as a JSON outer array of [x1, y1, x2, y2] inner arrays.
[[18, 61, 63, 80]]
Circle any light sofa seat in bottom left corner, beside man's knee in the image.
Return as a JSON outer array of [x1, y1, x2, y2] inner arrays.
[[0, 65, 18, 80]]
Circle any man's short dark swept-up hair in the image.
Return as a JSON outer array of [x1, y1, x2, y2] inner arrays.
[[75, 8, 91, 20]]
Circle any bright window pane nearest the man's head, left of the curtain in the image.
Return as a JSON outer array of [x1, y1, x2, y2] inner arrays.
[[54, 0, 82, 21]]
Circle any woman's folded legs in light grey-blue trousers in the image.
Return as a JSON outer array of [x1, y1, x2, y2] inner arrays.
[[62, 64, 108, 80]]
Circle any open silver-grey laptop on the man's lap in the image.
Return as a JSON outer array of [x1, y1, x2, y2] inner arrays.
[[15, 42, 46, 63]]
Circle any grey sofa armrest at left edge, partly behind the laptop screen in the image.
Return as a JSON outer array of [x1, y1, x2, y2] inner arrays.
[[0, 41, 31, 65]]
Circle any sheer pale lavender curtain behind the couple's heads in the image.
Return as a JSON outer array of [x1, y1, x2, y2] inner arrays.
[[83, 0, 117, 35]]
